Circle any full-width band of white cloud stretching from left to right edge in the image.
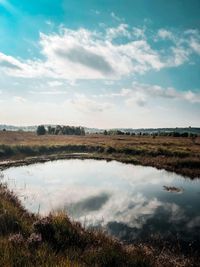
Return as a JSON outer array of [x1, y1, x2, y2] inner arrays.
[[0, 26, 200, 81]]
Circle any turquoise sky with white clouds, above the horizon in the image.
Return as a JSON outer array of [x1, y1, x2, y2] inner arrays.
[[0, 0, 200, 128]]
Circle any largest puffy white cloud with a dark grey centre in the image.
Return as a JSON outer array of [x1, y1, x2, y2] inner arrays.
[[38, 26, 162, 79]]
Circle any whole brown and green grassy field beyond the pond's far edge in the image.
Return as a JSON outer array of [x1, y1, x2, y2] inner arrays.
[[0, 132, 200, 178]]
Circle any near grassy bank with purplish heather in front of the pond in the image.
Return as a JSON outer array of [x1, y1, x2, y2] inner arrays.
[[0, 185, 199, 267]]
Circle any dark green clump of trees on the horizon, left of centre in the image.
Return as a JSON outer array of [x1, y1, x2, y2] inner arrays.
[[36, 125, 85, 135]]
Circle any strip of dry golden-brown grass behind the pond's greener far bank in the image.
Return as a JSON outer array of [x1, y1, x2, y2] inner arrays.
[[0, 132, 200, 154]]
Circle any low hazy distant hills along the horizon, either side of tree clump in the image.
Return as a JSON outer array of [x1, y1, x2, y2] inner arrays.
[[0, 124, 200, 135]]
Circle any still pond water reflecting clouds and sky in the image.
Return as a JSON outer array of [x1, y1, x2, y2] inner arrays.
[[1, 160, 200, 246]]
